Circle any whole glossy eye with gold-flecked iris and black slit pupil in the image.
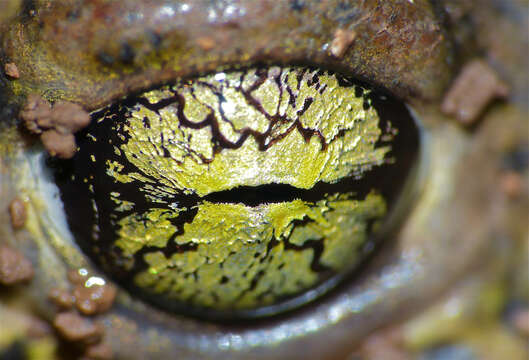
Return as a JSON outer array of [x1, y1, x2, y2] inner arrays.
[[51, 67, 418, 316]]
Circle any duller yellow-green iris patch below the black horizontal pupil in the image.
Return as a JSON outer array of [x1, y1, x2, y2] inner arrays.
[[136, 194, 386, 309]]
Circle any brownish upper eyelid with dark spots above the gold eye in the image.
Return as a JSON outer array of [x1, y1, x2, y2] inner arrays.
[[4, 0, 452, 110]]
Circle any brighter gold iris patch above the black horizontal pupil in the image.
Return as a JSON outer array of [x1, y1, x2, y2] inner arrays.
[[115, 68, 389, 196]]
